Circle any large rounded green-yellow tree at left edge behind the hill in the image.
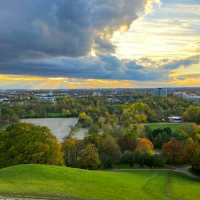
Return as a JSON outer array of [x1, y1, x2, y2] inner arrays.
[[0, 123, 63, 167]]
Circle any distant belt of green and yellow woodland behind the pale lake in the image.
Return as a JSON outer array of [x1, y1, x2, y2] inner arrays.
[[0, 95, 200, 126]]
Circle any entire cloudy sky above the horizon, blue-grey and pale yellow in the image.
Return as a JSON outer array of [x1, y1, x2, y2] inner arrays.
[[0, 0, 200, 89]]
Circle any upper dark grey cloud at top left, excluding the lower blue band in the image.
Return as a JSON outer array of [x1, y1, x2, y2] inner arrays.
[[0, 0, 145, 63]]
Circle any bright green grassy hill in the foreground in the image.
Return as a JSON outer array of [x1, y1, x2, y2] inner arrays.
[[0, 165, 200, 200]]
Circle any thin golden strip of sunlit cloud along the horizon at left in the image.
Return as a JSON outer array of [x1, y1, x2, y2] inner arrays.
[[0, 75, 136, 89]]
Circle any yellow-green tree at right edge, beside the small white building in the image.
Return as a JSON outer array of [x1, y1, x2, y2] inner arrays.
[[183, 105, 200, 124]]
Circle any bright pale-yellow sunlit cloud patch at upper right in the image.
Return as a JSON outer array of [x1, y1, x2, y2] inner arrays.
[[112, 12, 200, 61]]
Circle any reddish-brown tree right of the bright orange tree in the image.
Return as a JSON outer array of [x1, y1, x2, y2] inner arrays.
[[162, 139, 184, 164]]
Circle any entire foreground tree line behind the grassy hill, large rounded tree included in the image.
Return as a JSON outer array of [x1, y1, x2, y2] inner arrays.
[[0, 123, 200, 171]]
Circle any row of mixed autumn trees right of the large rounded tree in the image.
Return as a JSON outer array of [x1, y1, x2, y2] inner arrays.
[[64, 122, 200, 170]]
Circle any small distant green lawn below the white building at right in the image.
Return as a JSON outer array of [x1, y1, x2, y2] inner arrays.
[[145, 123, 194, 131]]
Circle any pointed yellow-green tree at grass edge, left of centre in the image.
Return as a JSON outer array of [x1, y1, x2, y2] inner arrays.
[[79, 144, 101, 170]]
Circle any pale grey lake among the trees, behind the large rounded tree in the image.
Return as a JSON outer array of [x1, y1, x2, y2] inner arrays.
[[21, 118, 87, 141]]
